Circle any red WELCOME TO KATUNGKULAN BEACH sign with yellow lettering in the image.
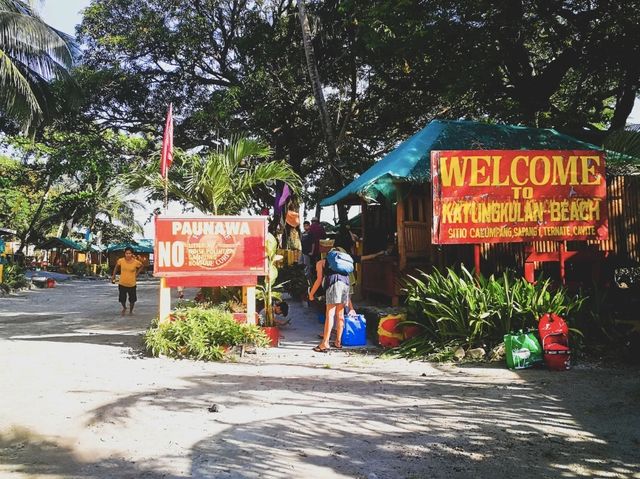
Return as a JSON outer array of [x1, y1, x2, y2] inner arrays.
[[431, 150, 608, 244]]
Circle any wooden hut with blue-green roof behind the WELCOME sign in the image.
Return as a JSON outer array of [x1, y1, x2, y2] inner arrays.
[[321, 120, 640, 304]]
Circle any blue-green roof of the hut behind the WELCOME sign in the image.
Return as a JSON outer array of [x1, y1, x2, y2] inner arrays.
[[320, 120, 602, 206]]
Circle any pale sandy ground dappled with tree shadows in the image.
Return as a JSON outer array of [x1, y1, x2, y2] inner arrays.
[[0, 281, 640, 479]]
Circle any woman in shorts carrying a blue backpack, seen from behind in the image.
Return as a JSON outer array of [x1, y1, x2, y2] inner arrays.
[[309, 239, 353, 353]]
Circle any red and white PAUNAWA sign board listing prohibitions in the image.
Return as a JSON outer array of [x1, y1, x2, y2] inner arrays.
[[154, 216, 267, 277]]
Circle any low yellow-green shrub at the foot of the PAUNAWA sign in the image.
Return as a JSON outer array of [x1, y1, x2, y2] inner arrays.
[[145, 307, 268, 361]]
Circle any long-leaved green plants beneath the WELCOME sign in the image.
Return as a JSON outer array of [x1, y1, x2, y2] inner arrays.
[[395, 266, 584, 357]]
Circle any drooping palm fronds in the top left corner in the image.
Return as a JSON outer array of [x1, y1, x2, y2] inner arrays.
[[0, 0, 75, 130]]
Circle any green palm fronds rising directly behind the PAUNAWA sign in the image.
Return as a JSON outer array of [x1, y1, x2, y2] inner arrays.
[[130, 138, 302, 215]]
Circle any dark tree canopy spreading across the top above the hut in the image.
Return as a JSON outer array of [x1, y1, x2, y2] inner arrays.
[[79, 0, 640, 208]]
